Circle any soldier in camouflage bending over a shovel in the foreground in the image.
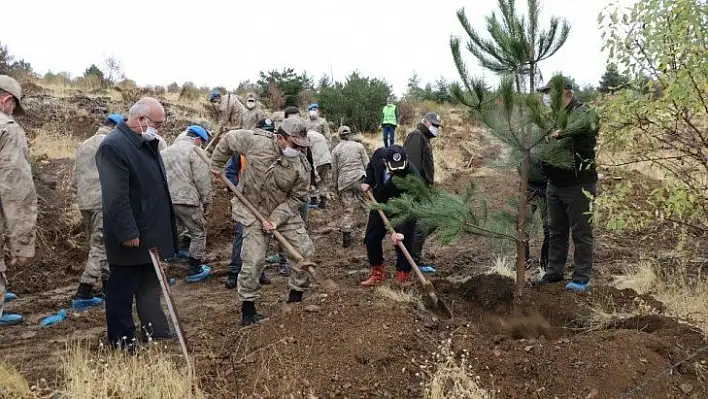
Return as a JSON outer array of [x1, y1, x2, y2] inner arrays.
[[211, 117, 314, 325]]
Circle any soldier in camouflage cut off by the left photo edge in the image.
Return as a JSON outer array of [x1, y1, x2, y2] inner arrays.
[[0, 75, 37, 326]]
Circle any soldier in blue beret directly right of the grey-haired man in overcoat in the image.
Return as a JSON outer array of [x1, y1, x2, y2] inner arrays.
[[160, 125, 212, 283]]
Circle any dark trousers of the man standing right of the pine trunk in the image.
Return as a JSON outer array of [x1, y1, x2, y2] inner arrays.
[[546, 183, 596, 283]]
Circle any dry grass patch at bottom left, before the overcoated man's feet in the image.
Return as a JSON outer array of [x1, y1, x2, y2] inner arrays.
[[61, 344, 204, 399]]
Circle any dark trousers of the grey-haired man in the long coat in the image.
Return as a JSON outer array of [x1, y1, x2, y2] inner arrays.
[[105, 264, 170, 345]]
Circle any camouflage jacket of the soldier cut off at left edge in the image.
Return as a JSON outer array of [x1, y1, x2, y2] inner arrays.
[[0, 112, 37, 260]]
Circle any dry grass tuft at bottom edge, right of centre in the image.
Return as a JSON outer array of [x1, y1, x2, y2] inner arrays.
[[418, 339, 494, 399]]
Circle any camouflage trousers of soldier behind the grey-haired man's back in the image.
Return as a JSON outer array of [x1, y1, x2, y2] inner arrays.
[[79, 209, 109, 286]]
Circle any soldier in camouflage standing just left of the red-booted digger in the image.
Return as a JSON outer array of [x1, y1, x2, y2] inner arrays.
[[332, 126, 369, 248]]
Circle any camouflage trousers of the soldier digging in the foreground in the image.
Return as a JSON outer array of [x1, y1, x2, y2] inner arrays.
[[236, 222, 315, 302]]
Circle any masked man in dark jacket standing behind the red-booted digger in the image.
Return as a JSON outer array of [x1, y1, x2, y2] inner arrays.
[[403, 112, 442, 273]]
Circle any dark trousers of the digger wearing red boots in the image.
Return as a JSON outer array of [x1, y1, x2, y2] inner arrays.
[[364, 211, 415, 272]]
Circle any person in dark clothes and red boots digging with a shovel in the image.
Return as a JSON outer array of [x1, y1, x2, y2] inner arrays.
[[360, 145, 420, 287]]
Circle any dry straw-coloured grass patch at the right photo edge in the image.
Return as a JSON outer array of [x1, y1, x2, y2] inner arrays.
[[613, 256, 708, 335]]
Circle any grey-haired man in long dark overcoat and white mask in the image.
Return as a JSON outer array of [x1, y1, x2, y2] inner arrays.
[[96, 97, 177, 347]]
